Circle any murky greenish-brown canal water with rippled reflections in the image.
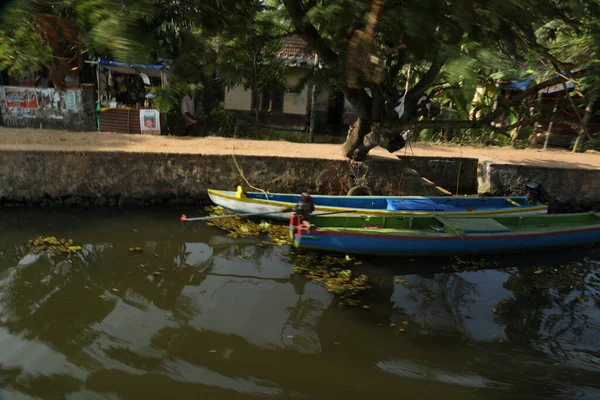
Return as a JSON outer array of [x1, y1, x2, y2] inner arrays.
[[0, 209, 600, 400]]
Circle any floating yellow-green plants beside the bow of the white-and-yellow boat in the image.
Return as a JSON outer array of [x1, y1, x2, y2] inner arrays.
[[206, 206, 290, 246]]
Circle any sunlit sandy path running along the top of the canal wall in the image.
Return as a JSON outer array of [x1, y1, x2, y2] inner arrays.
[[0, 127, 600, 169]]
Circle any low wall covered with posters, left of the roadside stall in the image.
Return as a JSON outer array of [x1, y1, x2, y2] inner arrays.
[[0, 85, 96, 131]]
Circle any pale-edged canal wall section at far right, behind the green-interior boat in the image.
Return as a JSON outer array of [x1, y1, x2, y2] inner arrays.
[[477, 161, 600, 212]]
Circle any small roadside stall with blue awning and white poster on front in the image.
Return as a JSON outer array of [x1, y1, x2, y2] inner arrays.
[[95, 59, 167, 135]]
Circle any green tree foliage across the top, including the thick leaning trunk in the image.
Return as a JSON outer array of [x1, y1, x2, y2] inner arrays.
[[0, 0, 600, 160]]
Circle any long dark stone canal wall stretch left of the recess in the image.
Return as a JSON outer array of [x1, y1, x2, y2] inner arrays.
[[0, 151, 446, 206]]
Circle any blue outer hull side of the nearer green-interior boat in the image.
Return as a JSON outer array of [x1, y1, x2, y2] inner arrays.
[[294, 226, 600, 256]]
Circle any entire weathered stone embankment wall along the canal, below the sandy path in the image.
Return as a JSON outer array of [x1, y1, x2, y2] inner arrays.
[[0, 150, 600, 212]]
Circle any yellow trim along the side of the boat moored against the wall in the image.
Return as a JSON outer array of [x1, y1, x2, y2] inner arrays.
[[208, 189, 548, 216]]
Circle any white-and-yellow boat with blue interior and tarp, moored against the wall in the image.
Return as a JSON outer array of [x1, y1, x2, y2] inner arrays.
[[208, 187, 548, 221]]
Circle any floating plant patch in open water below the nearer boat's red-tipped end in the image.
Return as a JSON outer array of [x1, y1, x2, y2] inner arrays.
[[287, 250, 370, 309]]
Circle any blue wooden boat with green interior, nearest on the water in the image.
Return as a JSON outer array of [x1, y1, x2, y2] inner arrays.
[[290, 213, 600, 256]]
